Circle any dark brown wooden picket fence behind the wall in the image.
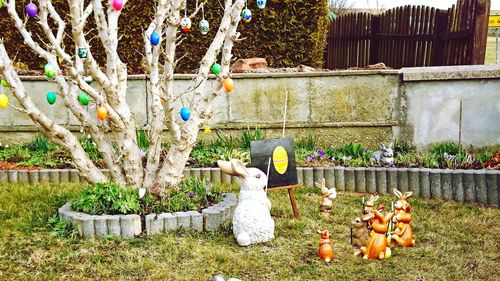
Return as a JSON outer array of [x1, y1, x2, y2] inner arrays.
[[327, 0, 490, 69]]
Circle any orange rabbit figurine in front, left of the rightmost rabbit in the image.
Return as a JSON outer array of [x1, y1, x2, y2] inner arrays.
[[360, 210, 394, 259]]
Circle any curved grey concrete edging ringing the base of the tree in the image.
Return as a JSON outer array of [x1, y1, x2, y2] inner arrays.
[[58, 193, 238, 239]]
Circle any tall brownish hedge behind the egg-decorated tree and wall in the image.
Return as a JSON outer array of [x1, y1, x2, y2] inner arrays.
[[0, 0, 328, 73]]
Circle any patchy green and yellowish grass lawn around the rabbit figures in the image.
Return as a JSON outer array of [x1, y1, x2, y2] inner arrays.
[[0, 185, 500, 280]]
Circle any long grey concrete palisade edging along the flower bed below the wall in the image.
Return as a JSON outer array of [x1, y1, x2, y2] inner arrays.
[[0, 167, 500, 207]]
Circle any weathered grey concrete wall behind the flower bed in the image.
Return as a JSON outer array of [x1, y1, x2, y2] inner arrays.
[[0, 66, 500, 148]]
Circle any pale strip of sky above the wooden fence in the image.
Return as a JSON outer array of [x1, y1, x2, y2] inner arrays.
[[351, 0, 500, 10]]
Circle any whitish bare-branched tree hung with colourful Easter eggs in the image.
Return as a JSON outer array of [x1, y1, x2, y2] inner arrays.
[[0, 0, 244, 193]]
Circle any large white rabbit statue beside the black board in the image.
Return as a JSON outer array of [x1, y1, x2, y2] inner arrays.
[[217, 159, 274, 246]]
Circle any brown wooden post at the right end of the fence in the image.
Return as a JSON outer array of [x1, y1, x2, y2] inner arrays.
[[470, 0, 491, 64]]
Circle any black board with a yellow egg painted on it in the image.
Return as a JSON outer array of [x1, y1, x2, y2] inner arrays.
[[250, 138, 298, 188]]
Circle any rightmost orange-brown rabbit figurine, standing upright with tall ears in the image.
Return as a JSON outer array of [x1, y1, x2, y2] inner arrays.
[[391, 189, 415, 247]]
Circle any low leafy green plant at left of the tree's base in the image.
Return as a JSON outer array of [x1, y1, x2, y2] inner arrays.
[[71, 183, 141, 215]]
